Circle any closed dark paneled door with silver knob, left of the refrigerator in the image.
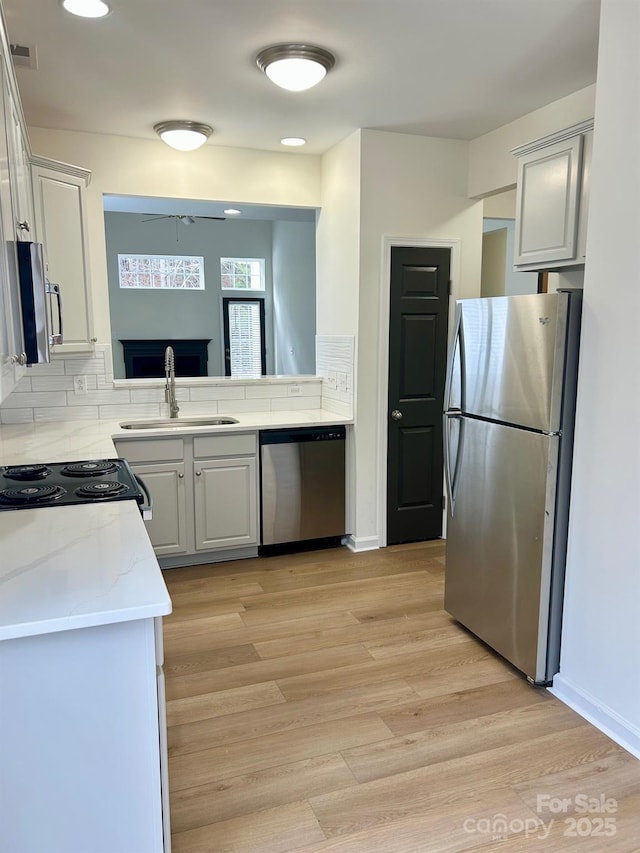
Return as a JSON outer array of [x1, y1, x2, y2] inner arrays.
[[387, 247, 451, 545]]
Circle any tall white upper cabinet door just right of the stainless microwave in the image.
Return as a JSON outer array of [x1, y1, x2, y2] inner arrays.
[[32, 158, 94, 353]]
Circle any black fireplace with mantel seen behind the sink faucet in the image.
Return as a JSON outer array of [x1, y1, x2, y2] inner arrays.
[[120, 338, 211, 379]]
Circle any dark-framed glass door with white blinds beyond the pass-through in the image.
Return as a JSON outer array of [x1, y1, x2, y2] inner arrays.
[[222, 297, 267, 376]]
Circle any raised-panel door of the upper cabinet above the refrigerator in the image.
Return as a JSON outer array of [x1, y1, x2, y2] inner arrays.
[[514, 136, 583, 265]]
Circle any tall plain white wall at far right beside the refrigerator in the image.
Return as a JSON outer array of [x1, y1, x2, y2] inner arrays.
[[554, 0, 640, 756]]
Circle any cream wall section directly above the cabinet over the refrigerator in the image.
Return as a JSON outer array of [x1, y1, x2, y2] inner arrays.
[[468, 85, 596, 198]]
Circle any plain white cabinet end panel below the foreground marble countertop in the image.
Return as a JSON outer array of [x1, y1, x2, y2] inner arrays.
[[0, 618, 169, 853]]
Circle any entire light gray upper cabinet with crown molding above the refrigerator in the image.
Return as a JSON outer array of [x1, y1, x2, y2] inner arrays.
[[512, 121, 593, 270]]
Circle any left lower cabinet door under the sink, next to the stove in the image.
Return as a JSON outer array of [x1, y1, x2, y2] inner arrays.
[[131, 462, 187, 557]]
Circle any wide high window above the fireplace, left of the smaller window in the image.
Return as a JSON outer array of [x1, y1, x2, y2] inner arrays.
[[118, 255, 204, 290]]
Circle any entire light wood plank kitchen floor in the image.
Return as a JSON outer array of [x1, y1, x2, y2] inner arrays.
[[165, 541, 640, 853]]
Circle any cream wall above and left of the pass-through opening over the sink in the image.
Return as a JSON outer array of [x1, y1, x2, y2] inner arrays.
[[29, 127, 320, 343]]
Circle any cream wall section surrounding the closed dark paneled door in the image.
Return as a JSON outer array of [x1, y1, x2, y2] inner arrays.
[[355, 130, 482, 544]]
